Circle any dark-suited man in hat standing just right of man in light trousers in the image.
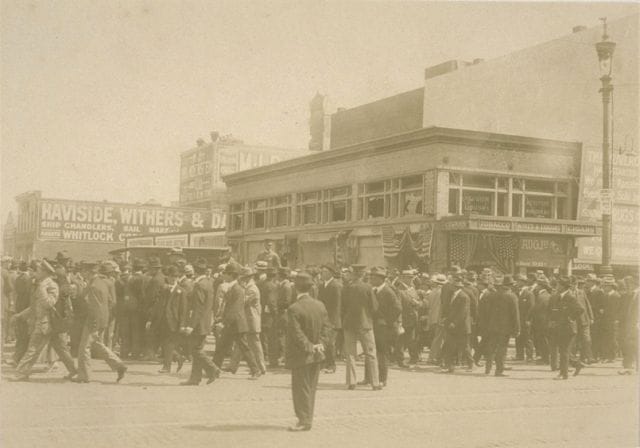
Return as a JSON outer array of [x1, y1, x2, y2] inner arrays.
[[365, 267, 402, 387]]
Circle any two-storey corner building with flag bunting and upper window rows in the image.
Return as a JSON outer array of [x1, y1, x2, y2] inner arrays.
[[224, 127, 600, 272]]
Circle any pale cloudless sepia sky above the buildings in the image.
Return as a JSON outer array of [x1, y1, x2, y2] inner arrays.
[[0, 0, 638, 223]]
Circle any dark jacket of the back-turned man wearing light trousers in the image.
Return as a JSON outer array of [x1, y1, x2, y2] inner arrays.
[[342, 279, 378, 331]]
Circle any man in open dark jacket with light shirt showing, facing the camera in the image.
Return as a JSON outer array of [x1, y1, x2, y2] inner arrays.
[[149, 265, 189, 373]]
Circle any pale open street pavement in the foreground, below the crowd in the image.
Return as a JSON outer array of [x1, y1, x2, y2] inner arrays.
[[0, 350, 638, 448]]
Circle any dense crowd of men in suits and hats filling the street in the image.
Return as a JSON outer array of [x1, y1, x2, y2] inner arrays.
[[2, 250, 639, 430]]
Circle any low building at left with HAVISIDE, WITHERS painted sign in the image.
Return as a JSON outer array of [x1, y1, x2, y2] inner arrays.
[[4, 191, 226, 261]]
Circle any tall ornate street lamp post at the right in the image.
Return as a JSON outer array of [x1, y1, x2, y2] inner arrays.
[[596, 18, 616, 275]]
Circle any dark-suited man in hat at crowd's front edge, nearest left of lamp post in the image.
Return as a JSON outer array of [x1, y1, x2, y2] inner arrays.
[[549, 277, 584, 380]]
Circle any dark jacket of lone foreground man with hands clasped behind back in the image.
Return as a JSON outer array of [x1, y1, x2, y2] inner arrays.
[[286, 294, 330, 369]]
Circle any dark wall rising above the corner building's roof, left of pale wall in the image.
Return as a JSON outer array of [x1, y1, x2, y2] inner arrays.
[[330, 88, 424, 149]]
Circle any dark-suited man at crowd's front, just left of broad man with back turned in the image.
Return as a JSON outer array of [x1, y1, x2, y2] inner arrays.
[[443, 276, 473, 373]]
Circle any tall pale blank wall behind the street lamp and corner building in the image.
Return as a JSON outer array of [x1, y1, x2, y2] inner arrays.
[[423, 15, 640, 264]]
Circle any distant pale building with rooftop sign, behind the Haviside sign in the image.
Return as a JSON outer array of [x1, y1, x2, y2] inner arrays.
[[180, 132, 307, 210]]
